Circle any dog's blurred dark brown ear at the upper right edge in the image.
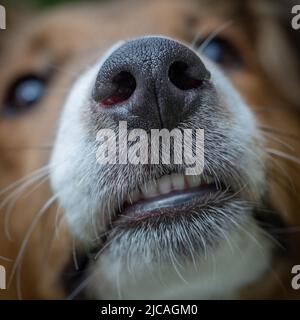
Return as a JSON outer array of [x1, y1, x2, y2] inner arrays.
[[258, 0, 300, 109]]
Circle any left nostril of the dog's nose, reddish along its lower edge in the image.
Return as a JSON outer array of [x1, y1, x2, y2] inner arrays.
[[101, 71, 136, 106]]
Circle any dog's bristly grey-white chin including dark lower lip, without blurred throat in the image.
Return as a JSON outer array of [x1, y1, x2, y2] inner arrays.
[[100, 183, 253, 264]]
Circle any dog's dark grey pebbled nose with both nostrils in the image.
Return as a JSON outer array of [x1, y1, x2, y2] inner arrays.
[[93, 36, 210, 129]]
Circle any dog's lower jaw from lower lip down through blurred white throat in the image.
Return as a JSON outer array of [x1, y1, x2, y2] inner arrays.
[[82, 194, 271, 299]]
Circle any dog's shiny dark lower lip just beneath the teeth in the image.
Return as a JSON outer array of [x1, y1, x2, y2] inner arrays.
[[121, 183, 224, 219]]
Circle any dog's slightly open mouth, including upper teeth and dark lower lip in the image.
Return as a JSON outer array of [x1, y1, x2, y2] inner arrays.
[[111, 173, 233, 226]]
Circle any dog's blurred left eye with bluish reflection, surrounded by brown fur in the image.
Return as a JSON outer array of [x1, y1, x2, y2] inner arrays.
[[3, 75, 46, 116]]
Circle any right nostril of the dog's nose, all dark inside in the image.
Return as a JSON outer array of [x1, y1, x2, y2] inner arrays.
[[169, 61, 202, 90]]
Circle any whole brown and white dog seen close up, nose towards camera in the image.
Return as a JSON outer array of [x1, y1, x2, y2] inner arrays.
[[0, 0, 300, 299]]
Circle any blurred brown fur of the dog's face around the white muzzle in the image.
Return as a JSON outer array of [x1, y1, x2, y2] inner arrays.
[[0, 0, 300, 299]]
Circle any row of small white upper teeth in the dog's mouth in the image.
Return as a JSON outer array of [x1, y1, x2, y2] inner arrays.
[[127, 174, 214, 204]]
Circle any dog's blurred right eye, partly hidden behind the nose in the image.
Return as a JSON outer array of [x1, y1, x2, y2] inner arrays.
[[197, 37, 244, 69]]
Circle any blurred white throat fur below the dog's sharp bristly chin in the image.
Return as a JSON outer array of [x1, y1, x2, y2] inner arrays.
[[85, 218, 272, 300]]
